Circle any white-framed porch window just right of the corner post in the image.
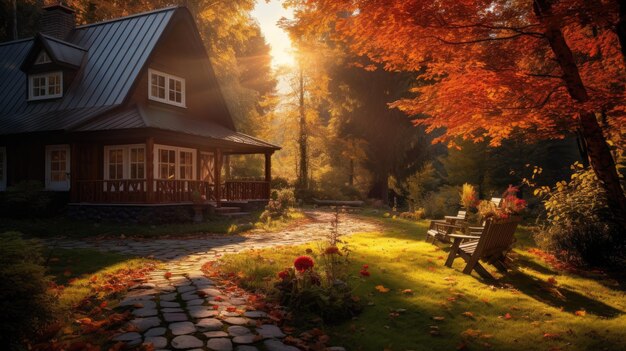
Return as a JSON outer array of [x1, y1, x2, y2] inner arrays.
[[154, 145, 196, 180]]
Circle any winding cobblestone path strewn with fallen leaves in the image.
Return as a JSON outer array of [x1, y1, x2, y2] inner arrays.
[[50, 211, 378, 351]]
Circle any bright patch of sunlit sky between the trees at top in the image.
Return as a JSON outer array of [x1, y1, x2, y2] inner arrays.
[[252, 0, 294, 68]]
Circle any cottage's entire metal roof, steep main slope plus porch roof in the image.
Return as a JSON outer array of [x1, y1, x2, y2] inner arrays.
[[0, 7, 280, 150]]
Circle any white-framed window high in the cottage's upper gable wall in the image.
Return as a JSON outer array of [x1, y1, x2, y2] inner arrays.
[[148, 69, 187, 107]]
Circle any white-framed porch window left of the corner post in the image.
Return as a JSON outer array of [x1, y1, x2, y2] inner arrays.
[[104, 144, 146, 180]]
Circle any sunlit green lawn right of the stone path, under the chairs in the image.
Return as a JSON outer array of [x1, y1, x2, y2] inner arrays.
[[213, 215, 626, 350]]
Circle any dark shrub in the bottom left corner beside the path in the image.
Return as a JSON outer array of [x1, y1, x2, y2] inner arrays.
[[0, 232, 56, 350]]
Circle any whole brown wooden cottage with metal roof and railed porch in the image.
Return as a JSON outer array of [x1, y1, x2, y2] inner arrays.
[[0, 5, 279, 220]]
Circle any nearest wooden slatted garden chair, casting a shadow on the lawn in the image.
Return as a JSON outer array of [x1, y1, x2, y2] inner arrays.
[[446, 217, 521, 280]]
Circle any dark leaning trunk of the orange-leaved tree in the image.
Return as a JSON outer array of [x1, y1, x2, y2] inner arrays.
[[533, 0, 626, 227]]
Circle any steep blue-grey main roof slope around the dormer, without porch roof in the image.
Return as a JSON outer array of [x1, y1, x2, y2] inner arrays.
[[0, 7, 177, 131]]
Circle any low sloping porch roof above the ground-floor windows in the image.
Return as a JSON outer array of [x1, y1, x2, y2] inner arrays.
[[71, 106, 280, 150]]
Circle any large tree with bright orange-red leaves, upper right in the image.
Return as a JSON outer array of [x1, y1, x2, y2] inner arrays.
[[288, 0, 626, 230]]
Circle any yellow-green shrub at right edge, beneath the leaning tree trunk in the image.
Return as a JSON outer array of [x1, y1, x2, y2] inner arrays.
[[535, 164, 626, 266]]
